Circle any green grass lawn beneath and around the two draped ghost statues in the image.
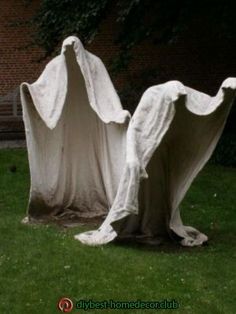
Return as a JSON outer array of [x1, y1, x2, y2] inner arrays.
[[0, 149, 236, 314]]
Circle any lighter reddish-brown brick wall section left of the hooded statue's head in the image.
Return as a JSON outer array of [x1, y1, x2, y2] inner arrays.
[[0, 0, 47, 95]]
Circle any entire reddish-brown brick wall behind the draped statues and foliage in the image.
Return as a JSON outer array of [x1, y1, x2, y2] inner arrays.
[[0, 0, 236, 115]]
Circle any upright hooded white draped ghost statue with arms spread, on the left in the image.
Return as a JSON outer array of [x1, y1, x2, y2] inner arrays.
[[21, 37, 130, 219]]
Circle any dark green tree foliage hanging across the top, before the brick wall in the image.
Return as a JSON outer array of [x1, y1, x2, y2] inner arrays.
[[28, 0, 236, 68]]
